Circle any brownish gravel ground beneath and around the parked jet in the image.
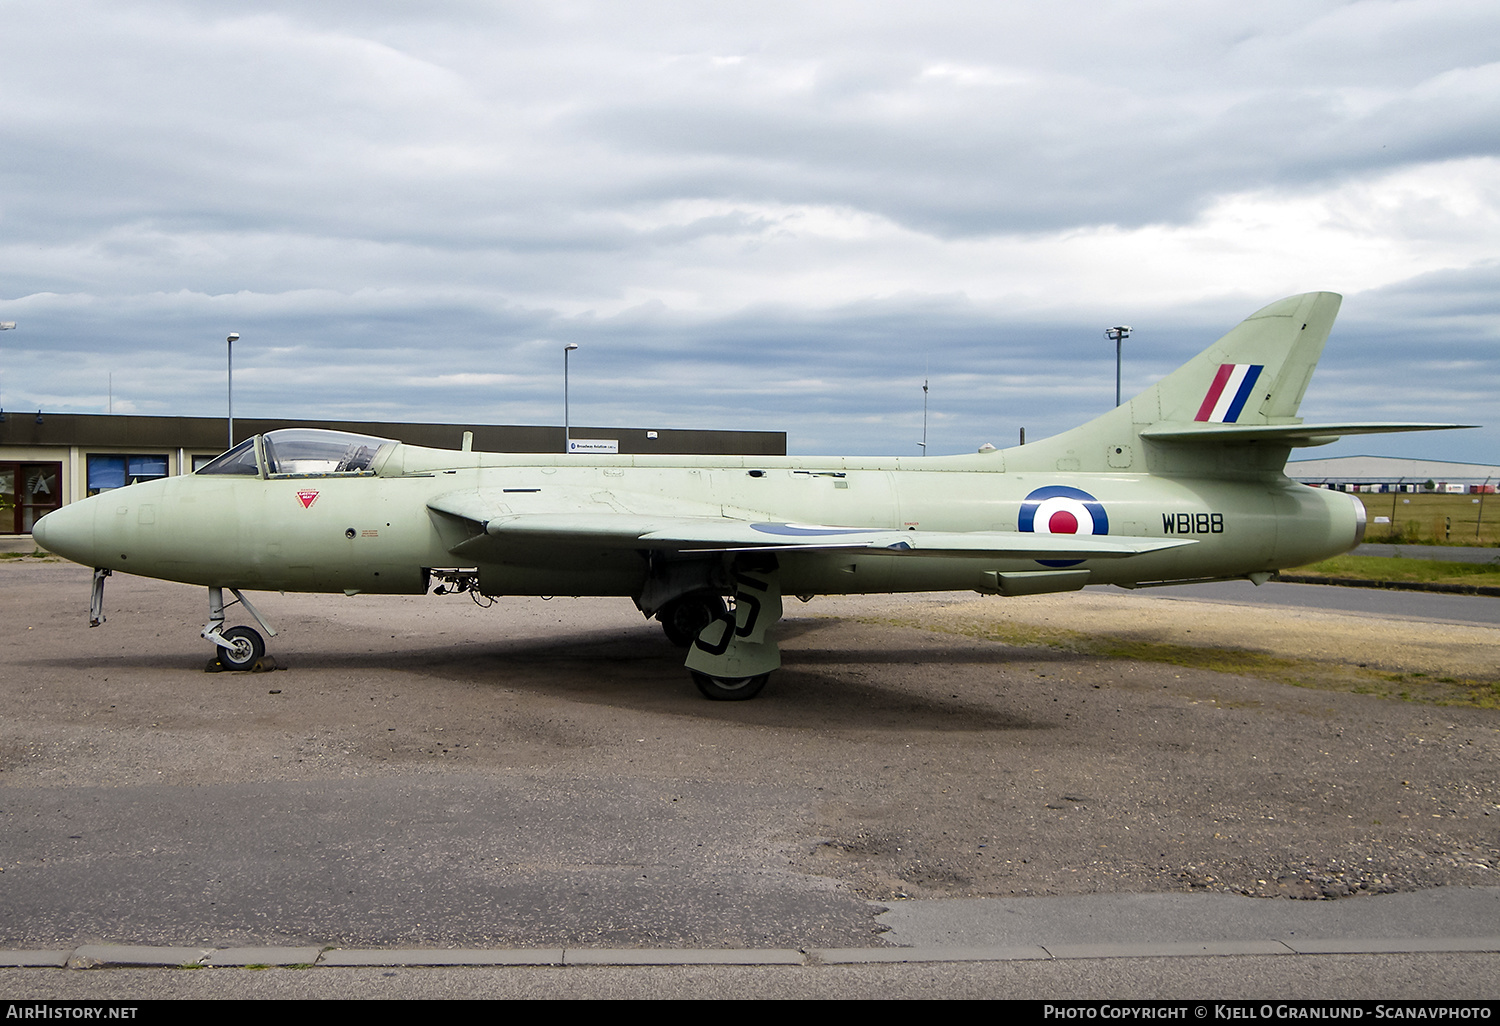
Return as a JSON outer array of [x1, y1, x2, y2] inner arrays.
[[0, 560, 1500, 924]]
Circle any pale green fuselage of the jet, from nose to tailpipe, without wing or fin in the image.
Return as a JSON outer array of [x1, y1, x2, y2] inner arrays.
[[39, 446, 1364, 597]]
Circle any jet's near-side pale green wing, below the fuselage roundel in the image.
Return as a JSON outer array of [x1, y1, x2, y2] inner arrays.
[[428, 492, 1196, 560]]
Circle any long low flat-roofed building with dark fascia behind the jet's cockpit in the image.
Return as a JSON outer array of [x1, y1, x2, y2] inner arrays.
[[0, 411, 786, 536]]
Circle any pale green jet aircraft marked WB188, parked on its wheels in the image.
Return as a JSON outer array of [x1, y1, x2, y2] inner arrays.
[[35, 293, 1461, 699]]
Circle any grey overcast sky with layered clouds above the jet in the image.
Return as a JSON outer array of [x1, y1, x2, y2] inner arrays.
[[0, 0, 1500, 462]]
